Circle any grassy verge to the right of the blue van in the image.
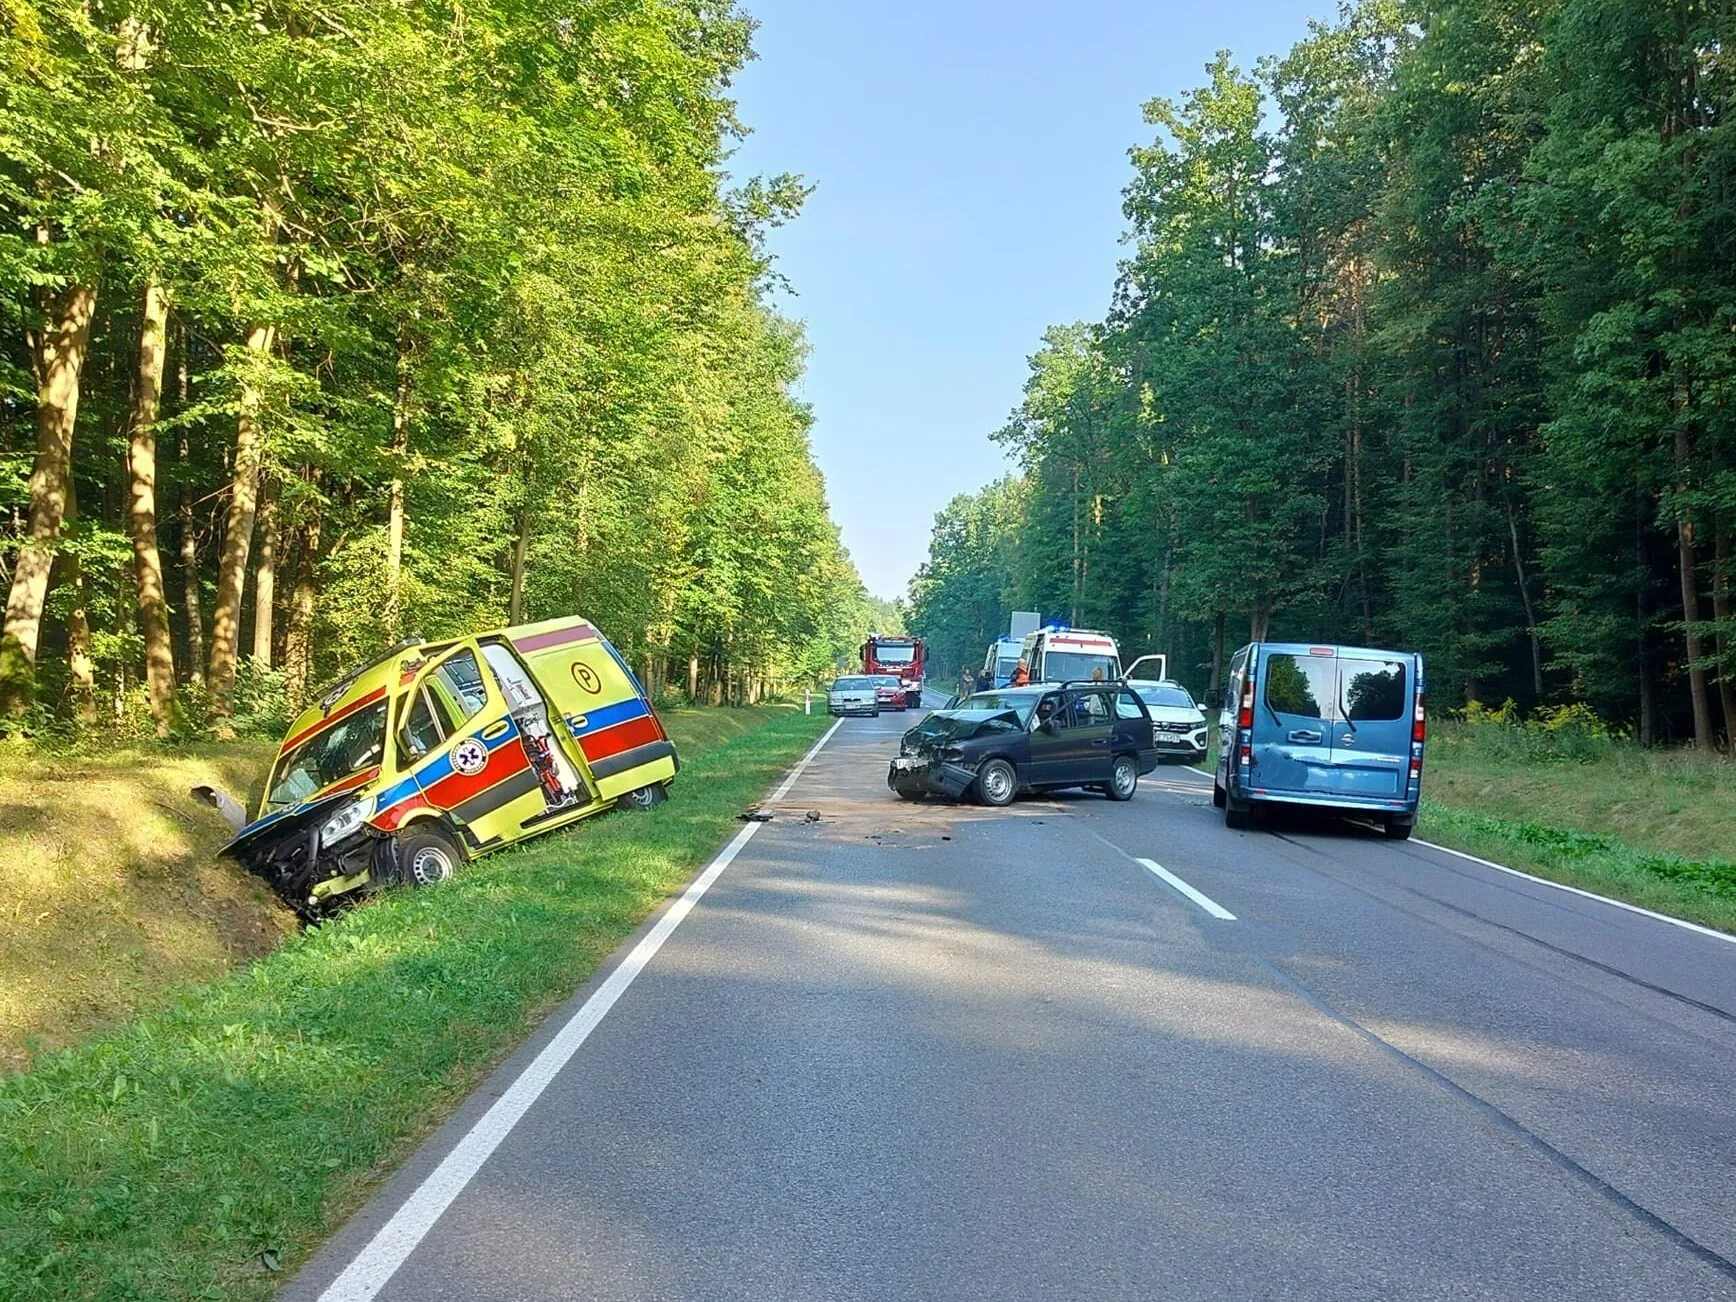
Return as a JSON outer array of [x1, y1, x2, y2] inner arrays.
[[1198, 712, 1736, 932]]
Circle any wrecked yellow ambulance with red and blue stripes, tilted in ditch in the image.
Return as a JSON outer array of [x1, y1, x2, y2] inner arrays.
[[206, 616, 679, 920]]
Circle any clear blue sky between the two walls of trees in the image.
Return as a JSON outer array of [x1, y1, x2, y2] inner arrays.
[[731, 0, 1337, 597]]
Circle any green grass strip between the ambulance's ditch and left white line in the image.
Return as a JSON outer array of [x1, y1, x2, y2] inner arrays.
[[0, 710, 828, 1299]]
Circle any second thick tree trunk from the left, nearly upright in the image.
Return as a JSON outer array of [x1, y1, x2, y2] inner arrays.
[[127, 279, 177, 736]]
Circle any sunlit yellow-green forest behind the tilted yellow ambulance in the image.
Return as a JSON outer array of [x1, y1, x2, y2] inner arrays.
[[0, 0, 868, 738]]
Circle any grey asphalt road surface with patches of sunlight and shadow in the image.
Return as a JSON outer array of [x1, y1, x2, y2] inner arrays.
[[286, 715, 1736, 1302]]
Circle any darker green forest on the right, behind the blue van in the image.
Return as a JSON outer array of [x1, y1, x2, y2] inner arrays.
[[910, 0, 1736, 750]]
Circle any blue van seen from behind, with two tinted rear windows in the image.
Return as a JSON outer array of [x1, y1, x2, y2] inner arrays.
[[1212, 642, 1425, 840]]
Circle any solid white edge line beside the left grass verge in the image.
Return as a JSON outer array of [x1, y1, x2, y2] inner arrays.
[[319, 719, 844, 1302]]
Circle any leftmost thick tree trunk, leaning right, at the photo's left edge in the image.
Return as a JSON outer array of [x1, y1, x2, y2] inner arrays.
[[0, 285, 97, 715]]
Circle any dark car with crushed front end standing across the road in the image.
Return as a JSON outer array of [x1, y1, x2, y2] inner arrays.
[[887, 682, 1158, 806]]
